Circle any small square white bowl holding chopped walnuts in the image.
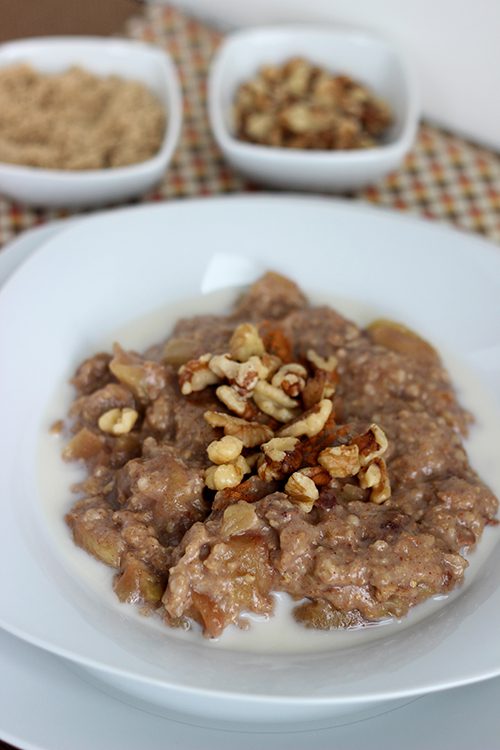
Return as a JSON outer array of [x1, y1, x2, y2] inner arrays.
[[208, 25, 418, 191]]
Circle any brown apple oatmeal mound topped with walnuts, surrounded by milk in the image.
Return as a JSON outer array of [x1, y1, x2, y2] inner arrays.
[[60, 273, 498, 637]]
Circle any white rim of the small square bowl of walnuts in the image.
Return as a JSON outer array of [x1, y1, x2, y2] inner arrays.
[[208, 23, 420, 167]]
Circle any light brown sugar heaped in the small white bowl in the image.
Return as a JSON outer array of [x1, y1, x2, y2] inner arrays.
[[0, 65, 165, 170]]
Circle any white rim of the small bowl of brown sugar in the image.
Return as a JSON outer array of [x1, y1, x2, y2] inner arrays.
[[0, 35, 182, 181]]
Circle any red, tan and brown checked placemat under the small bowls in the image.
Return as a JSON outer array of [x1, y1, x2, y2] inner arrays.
[[0, 5, 500, 246]]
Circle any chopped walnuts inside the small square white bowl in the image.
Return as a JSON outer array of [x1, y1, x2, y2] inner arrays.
[[233, 57, 392, 150]]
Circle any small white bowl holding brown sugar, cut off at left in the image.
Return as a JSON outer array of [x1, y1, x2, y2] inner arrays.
[[0, 37, 182, 207]]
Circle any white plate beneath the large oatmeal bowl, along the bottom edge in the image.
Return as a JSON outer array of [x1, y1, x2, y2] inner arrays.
[[0, 632, 500, 750]]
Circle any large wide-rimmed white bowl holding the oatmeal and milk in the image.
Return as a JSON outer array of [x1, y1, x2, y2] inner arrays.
[[0, 196, 500, 723]]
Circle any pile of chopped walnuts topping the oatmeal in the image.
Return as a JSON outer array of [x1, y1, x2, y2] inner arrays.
[[179, 323, 390, 510]]
